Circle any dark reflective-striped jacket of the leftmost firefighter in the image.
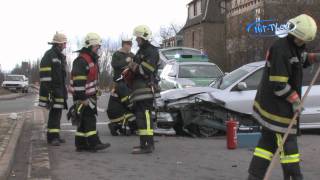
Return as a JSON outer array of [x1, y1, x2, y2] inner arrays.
[[39, 45, 68, 109]]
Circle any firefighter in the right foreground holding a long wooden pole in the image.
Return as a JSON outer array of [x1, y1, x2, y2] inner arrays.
[[248, 14, 317, 180]]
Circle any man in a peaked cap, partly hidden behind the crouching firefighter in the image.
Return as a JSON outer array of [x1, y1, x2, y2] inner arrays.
[[111, 38, 134, 82]]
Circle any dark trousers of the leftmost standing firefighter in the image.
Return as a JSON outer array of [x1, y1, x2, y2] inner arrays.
[[47, 108, 62, 143]]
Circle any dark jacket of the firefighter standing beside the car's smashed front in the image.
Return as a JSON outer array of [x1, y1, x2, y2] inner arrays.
[[130, 41, 159, 102]]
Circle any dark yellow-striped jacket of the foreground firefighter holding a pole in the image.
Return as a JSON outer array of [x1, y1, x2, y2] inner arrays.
[[253, 35, 310, 134]]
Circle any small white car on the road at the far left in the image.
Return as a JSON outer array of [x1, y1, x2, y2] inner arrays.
[[2, 74, 29, 93]]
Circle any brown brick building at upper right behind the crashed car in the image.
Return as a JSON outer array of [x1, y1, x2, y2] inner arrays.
[[183, 0, 320, 71]]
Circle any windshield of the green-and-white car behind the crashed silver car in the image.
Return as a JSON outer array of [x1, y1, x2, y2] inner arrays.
[[178, 64, 222, 78]]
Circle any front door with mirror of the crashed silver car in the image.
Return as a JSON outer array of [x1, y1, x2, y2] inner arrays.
[[222, 68, 263, 114]]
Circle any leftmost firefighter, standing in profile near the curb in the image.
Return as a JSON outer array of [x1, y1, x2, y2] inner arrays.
[[39, 32, 68, 146]]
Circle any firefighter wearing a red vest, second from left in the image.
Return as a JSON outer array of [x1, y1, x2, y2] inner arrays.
[[70, 33, 110, 152]]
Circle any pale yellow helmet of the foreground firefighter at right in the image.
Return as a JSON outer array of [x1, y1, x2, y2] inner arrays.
[[288, 14, 317, 42]]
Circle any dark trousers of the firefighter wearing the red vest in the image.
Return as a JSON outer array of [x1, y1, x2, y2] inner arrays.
[[75, 106, 101, 149]]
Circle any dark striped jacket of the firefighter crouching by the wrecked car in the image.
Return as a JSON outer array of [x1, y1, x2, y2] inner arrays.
[[107, 81, 135, 123]]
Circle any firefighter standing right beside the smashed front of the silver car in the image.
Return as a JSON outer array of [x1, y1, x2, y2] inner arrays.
[[124, 25, 159, 154]]
